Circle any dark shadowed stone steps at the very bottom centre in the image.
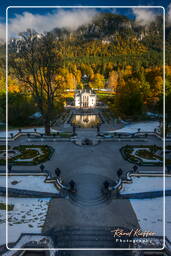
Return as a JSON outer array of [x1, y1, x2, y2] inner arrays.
[[52, 226, 132, 252]]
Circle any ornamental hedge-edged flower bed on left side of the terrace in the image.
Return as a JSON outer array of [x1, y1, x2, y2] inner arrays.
[[0, 145, 54, 165]]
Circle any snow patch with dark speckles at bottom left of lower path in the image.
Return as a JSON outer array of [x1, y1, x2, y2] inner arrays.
[[0, 197, 50, 245]]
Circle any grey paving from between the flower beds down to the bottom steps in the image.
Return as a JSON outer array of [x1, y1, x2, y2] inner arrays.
[[0, 129, 166, 251]]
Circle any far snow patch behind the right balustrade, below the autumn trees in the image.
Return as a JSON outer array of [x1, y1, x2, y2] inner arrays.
[[114, 121, 159, 133]]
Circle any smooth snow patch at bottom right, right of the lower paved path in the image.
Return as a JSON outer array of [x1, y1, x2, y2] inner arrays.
[[130, 196, 171, 240]]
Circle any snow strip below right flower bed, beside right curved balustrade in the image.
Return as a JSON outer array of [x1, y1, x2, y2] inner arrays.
[[120, 177, 171, 194]]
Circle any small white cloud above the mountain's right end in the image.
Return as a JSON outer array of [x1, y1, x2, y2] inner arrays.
[[133, 8, 156, 26]]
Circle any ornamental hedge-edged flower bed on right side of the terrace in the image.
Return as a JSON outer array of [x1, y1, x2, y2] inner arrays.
[[120, 145, 171, 166]]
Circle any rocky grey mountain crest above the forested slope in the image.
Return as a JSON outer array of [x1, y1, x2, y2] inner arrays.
[[53, 13, 162, 43]]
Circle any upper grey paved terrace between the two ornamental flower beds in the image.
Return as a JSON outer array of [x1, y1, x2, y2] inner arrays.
[[0, 134, 162, 174]]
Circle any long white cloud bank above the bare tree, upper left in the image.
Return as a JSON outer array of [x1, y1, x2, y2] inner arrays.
[[0, 9, 97, 39]]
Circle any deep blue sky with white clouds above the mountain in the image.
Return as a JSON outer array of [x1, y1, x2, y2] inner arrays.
[[0, 0, 171, 40]]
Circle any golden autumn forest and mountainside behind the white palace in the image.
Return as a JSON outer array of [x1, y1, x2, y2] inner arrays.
[[0, 13, 171, 126]]
